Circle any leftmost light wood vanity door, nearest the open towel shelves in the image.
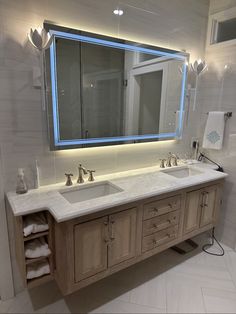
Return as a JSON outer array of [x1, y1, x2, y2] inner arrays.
[[74, 217, 108, 282]]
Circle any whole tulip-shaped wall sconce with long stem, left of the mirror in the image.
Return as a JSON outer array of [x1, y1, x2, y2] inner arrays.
[[28, 27, 53, 111]]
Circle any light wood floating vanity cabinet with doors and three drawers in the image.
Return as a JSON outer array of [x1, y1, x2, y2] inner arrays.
[[12, 180, 223, 295]]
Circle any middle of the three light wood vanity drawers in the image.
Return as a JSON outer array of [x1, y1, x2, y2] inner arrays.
[[143, 211, 180, 236]]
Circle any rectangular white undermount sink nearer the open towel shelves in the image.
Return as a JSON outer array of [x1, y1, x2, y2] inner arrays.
[[60, 181, 123, 204]]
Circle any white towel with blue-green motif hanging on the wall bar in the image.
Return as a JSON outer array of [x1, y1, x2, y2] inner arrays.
[[202, 111, 225, 150]]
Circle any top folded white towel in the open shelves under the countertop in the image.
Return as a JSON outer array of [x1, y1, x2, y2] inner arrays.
[[23, 213, 48, 237]]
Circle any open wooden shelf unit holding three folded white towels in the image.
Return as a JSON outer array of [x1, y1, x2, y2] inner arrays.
[[14, 211, 54, 288]]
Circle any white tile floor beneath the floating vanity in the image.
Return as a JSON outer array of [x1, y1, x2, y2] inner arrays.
[[0, 236, 236, 313]]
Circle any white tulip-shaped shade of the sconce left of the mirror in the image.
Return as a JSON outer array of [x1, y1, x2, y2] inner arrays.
[[28, 27, 52, 51]]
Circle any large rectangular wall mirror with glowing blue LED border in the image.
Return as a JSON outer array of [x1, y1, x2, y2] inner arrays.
[[46, 24, 188, 149]]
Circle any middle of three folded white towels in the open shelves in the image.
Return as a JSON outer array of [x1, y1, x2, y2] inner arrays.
[[25, 238, 51, 258]]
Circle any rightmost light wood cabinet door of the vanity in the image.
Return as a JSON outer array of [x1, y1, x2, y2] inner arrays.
[[200, 185, 219, 227]]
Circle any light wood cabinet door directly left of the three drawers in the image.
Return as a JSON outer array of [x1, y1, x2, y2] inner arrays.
[[108, 208, 137, 267]]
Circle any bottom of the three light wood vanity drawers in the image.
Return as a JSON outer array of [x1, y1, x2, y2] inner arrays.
[[142, 225, 178, 252]]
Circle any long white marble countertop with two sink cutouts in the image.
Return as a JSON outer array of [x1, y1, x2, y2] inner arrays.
[[7, 163, 227, 222]]
